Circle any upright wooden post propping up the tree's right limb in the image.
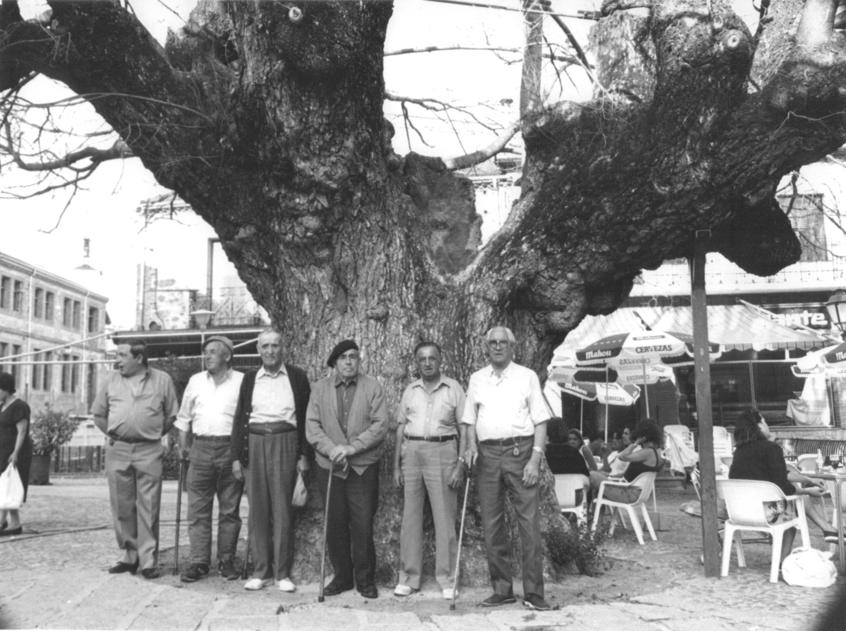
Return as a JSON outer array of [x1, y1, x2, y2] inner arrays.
[[690, 230, 721, 576]]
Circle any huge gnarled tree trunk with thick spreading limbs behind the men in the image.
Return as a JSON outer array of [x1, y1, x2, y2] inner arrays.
[[0, 0, 844, 582]]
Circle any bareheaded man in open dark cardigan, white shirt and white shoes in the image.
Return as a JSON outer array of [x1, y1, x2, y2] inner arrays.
[[231, 329, 310, 592]]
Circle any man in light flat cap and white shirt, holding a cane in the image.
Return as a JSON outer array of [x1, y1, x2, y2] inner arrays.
[[176, 335, 244, 583]]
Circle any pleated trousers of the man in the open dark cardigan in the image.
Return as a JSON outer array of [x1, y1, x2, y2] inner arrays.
[[246, 432, 297, 581]]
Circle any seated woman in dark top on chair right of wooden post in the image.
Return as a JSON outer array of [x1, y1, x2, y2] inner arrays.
[[729, 408, 837, 544]]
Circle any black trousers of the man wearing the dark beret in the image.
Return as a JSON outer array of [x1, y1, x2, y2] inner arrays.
[[317, 463, 379, 589]]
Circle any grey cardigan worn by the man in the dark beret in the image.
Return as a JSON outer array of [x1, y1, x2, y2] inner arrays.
[[306, 373, 388, 474]]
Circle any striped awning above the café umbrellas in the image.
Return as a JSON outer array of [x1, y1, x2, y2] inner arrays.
[[552, 305, 831, 363]]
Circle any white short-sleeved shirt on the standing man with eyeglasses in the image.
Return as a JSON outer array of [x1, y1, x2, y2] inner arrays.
[[461, 362, 550, 441]]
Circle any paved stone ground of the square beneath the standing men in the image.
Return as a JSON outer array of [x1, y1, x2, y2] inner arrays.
[[0, 478, 846, 631]]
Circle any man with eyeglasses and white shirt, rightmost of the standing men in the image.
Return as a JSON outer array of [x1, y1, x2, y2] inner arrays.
[[461, 326, 550, 611]]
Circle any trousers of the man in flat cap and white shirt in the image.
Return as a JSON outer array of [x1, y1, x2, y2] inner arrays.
[[186, 438, 244, 565]]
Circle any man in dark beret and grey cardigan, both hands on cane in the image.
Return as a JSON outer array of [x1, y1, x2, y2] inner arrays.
[[306, 340, 388, 598]]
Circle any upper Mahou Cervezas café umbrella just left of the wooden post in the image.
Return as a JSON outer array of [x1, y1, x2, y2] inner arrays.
[[576, 331, 720, 410]]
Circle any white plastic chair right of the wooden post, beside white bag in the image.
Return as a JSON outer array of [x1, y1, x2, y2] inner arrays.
[[717, 480, 811, 583]]
